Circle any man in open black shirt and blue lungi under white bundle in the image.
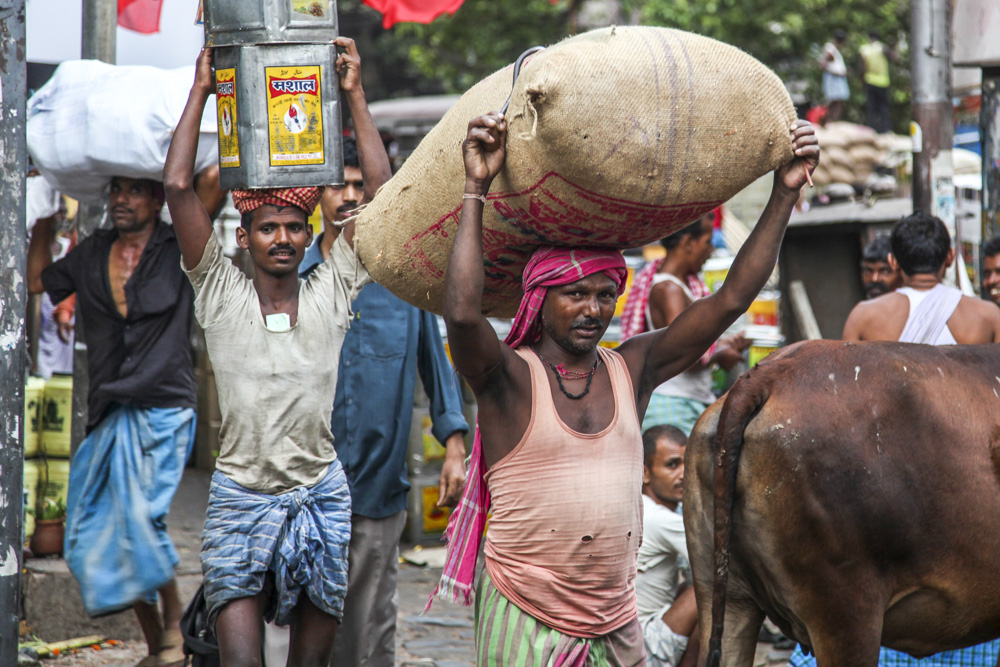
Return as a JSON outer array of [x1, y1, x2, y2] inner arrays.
[[28, 177, 196, 664]]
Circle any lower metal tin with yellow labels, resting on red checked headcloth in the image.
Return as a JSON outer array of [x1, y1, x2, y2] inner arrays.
[[215, 44, 344, 190]]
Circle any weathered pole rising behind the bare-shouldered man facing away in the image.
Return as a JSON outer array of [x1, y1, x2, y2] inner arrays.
[[910, 0, 955, 227]]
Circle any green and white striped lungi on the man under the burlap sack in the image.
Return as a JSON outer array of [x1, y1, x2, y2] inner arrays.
[[476, 571, 646, 667]]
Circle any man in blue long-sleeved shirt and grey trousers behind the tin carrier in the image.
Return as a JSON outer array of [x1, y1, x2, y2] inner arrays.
[[299, 138, 469, 667]]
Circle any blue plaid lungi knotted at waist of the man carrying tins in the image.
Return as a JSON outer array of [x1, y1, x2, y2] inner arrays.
[[201, 460, 351, 628]]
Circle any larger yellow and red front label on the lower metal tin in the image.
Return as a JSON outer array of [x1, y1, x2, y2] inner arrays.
[[264, 65, 326, 167]]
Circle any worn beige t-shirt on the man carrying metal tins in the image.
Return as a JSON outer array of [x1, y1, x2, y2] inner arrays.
[[184, 234, 371, 494]]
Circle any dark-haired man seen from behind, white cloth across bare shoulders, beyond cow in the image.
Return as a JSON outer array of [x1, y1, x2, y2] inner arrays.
[[843, 212, 1000, 345]]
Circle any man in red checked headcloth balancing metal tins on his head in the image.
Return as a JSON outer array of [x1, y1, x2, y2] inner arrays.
[[164, 37, 390, 667]]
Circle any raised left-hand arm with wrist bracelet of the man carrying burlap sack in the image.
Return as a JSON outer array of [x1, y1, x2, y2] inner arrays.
[[444, 112, 507, 391]]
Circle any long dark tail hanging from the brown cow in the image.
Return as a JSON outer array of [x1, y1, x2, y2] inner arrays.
[[707, 369, 770, 667]]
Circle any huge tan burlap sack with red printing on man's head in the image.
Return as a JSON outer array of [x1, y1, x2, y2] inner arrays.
[[356, 27, 795, 317]]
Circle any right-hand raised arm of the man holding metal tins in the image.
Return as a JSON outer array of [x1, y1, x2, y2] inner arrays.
[[333, 37, 392, 246]]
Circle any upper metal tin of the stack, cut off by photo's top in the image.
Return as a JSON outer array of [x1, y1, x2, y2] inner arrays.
[[204, 0, 337, 46]]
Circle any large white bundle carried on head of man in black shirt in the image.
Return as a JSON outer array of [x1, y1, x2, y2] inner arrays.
[[27, 60, 218, 201]]
